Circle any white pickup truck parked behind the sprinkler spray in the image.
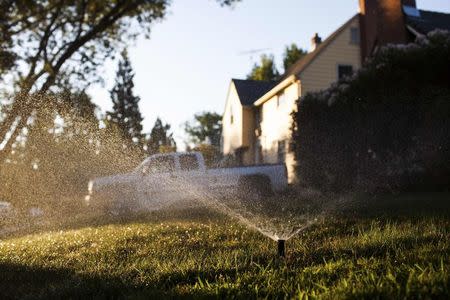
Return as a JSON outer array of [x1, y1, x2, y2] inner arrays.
[[85, 152, 287, 213]]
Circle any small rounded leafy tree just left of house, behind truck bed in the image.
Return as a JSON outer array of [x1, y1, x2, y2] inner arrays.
[[184, 112, 222, 147]]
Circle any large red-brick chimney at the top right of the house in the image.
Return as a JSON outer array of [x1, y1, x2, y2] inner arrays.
[[359, 0, 416, 61]]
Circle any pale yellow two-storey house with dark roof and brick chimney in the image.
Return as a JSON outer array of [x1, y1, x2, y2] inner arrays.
[[222, 0, 450, 182]]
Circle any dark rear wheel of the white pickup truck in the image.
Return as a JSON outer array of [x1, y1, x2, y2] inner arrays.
[[238, 175, 273, 200]]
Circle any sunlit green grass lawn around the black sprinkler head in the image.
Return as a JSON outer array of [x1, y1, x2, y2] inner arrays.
[[0, 193, 450, 299]]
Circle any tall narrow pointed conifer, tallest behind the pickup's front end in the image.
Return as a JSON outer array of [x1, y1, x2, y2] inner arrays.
[[107, 51, 143, 145]]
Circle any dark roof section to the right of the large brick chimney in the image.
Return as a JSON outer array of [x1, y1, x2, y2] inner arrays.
[[405, 10, 450, 34]]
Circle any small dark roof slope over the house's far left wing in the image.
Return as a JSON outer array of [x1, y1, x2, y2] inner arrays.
[[232, 79, 277, 106]]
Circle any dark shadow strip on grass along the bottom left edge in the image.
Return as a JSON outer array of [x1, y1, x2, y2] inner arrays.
[[0, 263, 246, 299]]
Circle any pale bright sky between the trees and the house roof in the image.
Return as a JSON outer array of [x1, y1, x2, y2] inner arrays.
[[89, 0, 450, 149]]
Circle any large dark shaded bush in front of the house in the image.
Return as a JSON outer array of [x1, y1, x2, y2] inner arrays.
[[292, 31, 450, 191]]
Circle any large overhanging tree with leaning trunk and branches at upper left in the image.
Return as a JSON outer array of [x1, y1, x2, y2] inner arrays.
[[0, 0, 241, 161]]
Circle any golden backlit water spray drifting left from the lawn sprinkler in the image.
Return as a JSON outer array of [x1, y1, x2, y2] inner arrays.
[[0, 94, 358, 241]]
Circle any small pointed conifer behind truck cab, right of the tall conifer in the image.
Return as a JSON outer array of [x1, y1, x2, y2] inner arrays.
[[146, 118, 177, 154]]
